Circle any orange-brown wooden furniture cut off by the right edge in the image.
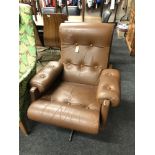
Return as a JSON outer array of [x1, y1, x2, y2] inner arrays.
[[126, 9, 135, 55]]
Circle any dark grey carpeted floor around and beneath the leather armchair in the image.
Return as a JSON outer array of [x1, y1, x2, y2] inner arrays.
[[19, 31, 135, 155]]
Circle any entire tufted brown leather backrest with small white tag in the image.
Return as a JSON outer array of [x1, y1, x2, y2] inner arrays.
[[59, 23, 114, 85]]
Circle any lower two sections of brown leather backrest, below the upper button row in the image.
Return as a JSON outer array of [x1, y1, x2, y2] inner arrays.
[[61, 46, 109, 85]]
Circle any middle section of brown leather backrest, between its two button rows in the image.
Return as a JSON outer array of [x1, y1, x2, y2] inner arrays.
[[61, 45, 110, 69]]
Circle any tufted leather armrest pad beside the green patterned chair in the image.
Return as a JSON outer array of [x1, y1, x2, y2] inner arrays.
[[30, 61, 63, 93]]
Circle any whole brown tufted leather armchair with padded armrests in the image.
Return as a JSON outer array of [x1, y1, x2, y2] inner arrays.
[[27, 23, 120, 134]]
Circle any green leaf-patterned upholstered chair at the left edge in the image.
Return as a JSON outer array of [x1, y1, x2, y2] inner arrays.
[[19, 4, 36, 134]]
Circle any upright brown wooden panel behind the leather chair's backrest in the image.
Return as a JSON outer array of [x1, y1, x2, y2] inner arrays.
[[43, 13, 68, 48]]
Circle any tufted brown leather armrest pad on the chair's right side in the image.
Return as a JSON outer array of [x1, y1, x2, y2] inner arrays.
[[97, 69, 120, 107]]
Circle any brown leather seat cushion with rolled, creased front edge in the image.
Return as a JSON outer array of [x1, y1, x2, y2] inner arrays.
[[28, 82, 100, 134]]
